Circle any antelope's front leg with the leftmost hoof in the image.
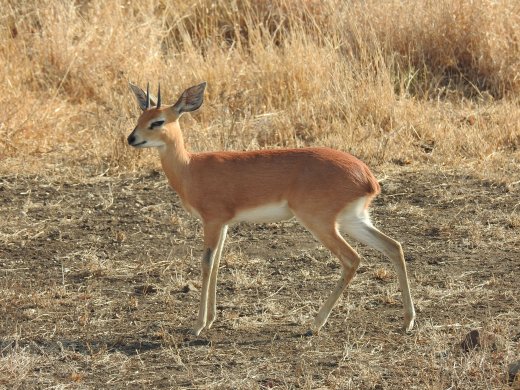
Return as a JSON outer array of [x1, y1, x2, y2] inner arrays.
[[193, 223, 222, 336]]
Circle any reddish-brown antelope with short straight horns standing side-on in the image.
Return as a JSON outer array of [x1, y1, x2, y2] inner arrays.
[[128, 82, 415, 336]]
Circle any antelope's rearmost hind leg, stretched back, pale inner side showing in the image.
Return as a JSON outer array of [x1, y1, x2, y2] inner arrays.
[[342, 218, 415, 332]]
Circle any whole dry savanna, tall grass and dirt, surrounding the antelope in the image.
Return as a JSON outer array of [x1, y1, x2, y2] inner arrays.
[[0, 0, 520, 389]]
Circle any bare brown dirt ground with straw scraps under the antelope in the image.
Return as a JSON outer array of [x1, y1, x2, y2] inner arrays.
[[0, 166, 520, 389]]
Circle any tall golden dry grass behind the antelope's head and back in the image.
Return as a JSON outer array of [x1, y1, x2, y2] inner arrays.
[[0, 0, 520, 177]]
